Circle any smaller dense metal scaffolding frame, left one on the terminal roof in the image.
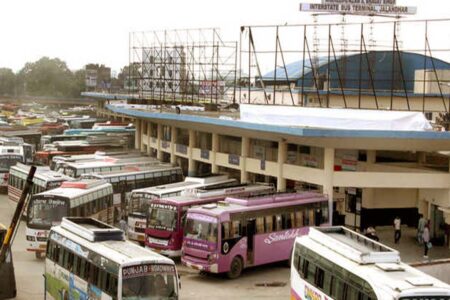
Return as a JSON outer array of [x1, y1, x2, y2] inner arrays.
[[129, 28, 237, 105]]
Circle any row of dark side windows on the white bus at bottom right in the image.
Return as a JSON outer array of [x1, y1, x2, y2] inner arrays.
[[293, 247, 377, 300]]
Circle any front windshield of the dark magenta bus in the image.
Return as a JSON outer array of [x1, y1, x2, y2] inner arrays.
[[148, 203, 177, 231]]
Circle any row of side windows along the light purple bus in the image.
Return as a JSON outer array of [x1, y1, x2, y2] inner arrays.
[[222, 202, 328, 239]]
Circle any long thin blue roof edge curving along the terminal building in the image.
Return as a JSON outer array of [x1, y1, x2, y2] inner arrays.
[[106, 105, 450, 141]]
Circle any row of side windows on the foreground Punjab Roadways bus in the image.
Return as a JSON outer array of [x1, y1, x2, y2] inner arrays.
[[47, 240, 118, 299]]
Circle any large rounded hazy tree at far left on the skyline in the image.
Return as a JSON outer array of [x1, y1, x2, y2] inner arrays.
[[19, 57, 83, 97]]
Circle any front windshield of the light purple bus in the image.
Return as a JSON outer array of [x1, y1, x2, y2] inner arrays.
[[185, 214, 217, 243]]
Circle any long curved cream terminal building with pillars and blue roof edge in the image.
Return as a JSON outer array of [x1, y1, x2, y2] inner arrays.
[[98, 100, 450, 245]]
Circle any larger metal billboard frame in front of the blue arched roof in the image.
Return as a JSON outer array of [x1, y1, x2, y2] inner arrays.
[[238, 19, 450, 112]]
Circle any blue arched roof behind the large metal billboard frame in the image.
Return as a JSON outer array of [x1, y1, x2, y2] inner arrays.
[[263, 51, 450, 95]]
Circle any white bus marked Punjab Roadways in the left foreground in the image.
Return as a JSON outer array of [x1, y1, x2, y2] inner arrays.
[[45, 218, 179, 300]]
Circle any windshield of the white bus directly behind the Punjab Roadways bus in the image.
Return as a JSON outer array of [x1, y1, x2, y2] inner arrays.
[[28, 199, 68, 228]]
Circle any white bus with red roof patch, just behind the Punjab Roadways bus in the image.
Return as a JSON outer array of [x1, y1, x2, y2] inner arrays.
[[25, 180, 114, 257]]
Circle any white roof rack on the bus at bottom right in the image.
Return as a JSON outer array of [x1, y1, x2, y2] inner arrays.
[[308, 226, 400, 264]]
